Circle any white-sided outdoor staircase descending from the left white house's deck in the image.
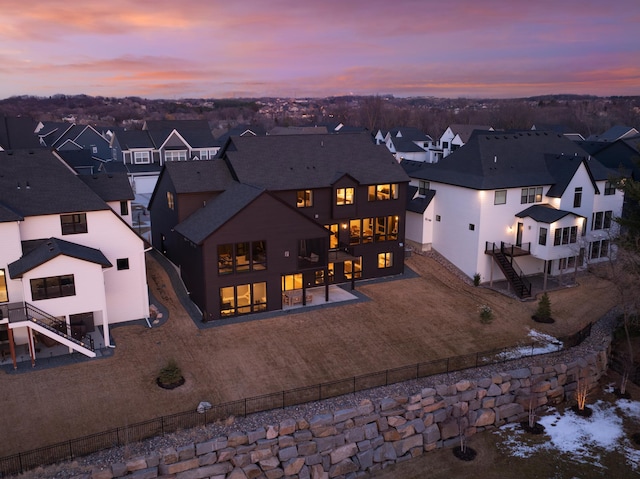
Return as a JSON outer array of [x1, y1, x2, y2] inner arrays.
[[8, 303, 96, 358]]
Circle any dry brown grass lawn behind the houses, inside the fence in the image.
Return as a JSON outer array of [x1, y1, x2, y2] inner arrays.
[[0, 256, 615, 455]]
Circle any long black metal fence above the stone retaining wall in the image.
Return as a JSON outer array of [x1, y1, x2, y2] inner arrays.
[[0, 323, 592, 477]]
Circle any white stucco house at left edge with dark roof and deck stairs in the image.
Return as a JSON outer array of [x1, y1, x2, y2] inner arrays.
[[0, 150, 149, 367]]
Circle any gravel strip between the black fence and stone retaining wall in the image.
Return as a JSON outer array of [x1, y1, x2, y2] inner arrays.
[[8, 311, 617, 479]]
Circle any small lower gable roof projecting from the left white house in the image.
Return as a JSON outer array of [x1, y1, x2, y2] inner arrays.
[[9, 238, 113, 279]]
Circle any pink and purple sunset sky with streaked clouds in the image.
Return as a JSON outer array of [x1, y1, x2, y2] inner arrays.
[[0, 0, 640, 99]]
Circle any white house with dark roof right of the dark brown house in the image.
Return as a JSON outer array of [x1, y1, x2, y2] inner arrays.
[[403, 131, 623, 294]]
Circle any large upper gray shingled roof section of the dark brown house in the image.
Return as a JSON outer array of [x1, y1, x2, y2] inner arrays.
[[221, 132, 409, 190]]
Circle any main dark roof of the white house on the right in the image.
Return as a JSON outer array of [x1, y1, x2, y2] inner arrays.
[[402, 131, 611, 195]]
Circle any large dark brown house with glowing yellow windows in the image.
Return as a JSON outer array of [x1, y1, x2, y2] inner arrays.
[[149, 133, 409, 321]]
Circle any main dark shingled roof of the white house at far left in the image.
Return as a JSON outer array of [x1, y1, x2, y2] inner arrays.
[[0, 150, 109, 221]]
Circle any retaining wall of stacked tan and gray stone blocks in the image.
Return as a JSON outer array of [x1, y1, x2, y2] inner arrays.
[[91, 343, 608, 479]]
